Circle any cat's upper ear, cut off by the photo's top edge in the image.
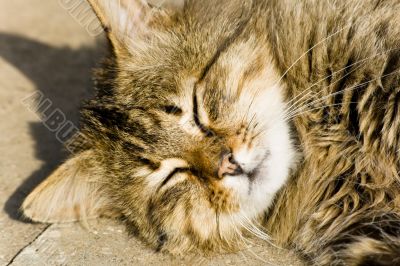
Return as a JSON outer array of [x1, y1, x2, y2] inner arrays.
[[88, 0, 185, 50]]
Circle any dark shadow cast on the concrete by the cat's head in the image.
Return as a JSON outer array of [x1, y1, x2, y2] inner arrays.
[[0, 33, 104, 221]]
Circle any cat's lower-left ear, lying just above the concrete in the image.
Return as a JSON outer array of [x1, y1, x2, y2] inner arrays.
[[22, 150, 114, 223]]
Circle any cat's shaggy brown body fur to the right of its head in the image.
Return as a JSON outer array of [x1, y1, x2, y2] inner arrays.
[[267, 1, 400, 265]]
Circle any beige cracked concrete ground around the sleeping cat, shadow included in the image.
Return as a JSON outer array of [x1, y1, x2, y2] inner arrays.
[[0, 0, 302, 265]]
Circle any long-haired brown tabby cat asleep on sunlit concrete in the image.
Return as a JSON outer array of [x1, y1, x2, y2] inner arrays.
[[22, 0, 400, 265]]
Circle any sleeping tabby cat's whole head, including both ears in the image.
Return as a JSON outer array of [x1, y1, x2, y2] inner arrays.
[[23, 0, 295, 254]]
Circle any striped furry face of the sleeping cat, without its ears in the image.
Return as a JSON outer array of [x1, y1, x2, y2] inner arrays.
[[82, 1, 295, 255]]
